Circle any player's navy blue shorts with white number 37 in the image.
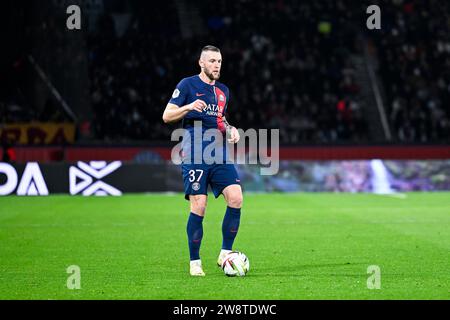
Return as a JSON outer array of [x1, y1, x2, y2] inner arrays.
[[181, 163, 241, 200]]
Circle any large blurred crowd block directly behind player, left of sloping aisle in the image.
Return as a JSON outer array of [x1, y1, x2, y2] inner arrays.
[[90, 1, 368, 143]]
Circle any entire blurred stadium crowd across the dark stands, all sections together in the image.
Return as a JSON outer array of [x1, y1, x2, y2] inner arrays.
[[0, 0, 450, 144]]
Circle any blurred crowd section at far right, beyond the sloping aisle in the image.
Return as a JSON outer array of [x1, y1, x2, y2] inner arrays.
[[372, 0, 450, 143]]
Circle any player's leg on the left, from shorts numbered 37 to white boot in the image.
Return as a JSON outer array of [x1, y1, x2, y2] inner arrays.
[[182, 165, 208, 276]]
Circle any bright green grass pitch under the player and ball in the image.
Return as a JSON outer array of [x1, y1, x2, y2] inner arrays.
[[0, 193, 450, 300]]
